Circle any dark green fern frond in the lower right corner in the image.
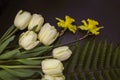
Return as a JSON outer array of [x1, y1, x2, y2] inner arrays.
[[64, 41, 120, 80]]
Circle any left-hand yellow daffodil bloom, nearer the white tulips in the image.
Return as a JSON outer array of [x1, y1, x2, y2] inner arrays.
[[56, 16, 77, 33]]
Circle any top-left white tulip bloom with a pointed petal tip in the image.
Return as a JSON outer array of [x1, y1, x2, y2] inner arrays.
[[14, 10, 31, 30]]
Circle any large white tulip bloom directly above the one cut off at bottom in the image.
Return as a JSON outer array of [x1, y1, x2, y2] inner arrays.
[[41, 59, 64, 75]]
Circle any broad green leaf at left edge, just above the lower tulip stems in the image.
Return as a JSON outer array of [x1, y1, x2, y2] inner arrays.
[[0, 49, 20, 59]]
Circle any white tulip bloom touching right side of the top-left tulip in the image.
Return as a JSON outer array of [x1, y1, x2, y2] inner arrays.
[[28, 14, 44, 32]]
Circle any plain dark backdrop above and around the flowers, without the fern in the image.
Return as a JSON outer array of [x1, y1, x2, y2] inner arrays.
[[0, 0, 120, 44]]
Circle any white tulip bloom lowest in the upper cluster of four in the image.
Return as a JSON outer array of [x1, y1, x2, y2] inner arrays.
[[19, 31, 39, 50]]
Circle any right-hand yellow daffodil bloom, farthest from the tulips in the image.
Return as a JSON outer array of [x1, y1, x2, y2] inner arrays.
[[79, 19, 103, 35]]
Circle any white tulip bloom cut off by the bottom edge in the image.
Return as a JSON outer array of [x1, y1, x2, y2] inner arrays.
[[41, 75, 65, 80]]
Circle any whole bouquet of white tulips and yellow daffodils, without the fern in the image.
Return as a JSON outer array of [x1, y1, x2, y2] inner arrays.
[[0, 10, 119, 80]]
